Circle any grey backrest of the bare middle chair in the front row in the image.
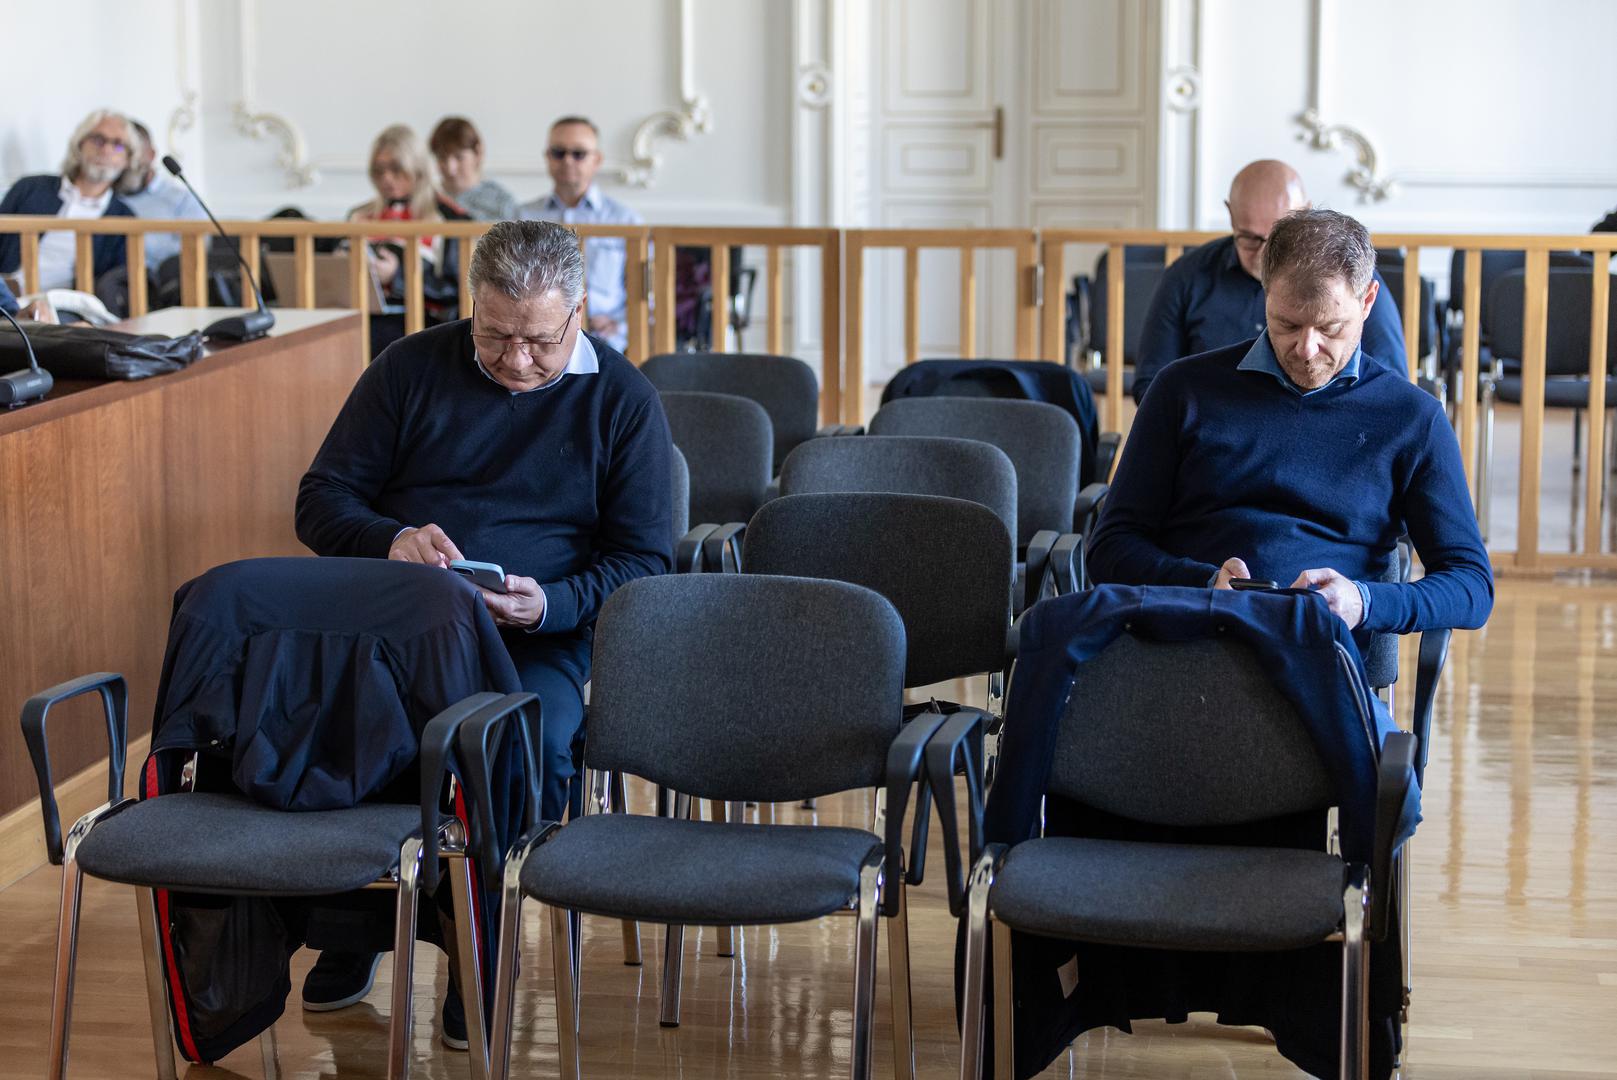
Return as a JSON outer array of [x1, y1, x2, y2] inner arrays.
[[584, 574, 904, 802]]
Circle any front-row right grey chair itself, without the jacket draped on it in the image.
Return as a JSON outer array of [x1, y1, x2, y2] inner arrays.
[[927, 634, 1415, 1077]]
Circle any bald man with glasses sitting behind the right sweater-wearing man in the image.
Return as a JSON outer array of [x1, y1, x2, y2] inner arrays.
[[1134, 160, 1408, 403]]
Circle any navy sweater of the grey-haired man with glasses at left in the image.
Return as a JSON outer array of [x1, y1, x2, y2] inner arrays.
[[298, 320, 673, 635]]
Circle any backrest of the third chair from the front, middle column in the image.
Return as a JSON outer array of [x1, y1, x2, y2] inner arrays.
[[781, 435, 1017, 534]]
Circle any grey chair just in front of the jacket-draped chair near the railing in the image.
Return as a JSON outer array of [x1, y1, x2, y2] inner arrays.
[[870, 398, 1108, 603]]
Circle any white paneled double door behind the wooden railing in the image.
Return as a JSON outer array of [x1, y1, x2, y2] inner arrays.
[[854, 0, 1159, 380]]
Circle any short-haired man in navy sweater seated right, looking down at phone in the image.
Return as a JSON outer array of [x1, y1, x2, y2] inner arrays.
[[1088, 210, 1494, 648]]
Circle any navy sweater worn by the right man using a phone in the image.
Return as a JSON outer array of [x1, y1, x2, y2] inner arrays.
[[1088, 341, 1494, 645]]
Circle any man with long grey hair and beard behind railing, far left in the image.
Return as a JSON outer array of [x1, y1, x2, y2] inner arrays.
[[0, 108, 141, 291]]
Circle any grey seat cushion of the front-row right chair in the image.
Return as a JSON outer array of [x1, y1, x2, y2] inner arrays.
[[990, 837, 1344, 951]]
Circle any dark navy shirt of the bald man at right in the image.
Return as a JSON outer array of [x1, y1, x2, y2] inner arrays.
[[1134, 236, 1408, 403]]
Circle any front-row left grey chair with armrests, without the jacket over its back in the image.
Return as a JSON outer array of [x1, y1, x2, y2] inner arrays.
[[23, 673, 500, 1080]]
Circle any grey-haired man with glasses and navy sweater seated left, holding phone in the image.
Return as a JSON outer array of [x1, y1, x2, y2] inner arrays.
[[298, 221, 673, 1049]]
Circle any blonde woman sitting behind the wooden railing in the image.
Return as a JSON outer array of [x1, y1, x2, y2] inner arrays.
[[348, 124, 469, 354]]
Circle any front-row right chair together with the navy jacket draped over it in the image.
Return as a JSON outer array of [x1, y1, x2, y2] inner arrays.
[[927, 587, 1415, 1077]]
